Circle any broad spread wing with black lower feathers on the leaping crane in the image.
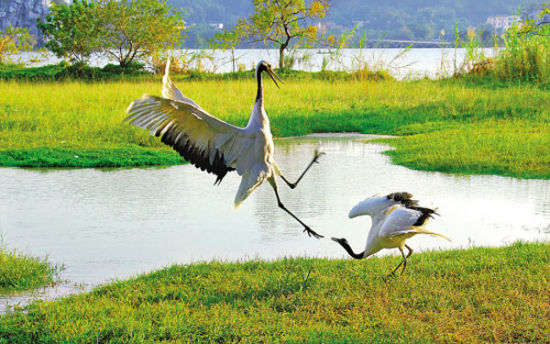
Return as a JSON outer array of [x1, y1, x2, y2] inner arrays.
[[125, 95, 263, 183]]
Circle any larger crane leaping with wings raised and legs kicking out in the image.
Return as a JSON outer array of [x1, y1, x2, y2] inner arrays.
[[126, 59, 323, 238]]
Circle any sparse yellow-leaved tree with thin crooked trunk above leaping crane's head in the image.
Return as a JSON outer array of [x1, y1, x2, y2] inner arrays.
[[215, 0, 329, 68]]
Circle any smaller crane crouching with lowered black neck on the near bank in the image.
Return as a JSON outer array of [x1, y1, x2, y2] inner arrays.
[[332, 192, 450, 277]]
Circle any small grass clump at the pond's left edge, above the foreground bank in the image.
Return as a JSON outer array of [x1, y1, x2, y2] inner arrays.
[[0, 246, 59, 294]]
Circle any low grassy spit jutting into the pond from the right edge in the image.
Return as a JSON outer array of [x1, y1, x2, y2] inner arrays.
[[376, 120, 550, 179]]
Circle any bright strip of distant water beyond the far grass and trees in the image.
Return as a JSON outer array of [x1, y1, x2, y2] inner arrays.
[[14, 48, 495, 79]]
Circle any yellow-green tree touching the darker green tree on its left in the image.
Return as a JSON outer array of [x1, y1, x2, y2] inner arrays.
[[100, 0, 184, 67]]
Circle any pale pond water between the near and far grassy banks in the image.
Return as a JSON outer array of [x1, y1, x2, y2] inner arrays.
[[0, 135, 550, 307]]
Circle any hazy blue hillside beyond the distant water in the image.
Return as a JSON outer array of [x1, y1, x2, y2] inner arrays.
[[168, 0, 544, 47]]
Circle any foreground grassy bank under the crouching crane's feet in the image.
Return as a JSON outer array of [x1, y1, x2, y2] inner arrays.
[[0, 243, 550, 343]]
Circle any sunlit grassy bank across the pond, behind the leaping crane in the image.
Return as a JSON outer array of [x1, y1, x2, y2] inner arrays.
[[0, 78, 550, 179]]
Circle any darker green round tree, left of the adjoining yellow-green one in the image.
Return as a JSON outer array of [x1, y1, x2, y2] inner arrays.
[[38, 0, 105, 62]]
